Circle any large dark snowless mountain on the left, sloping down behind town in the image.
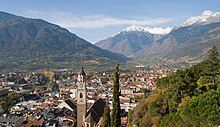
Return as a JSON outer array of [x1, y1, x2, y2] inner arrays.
[[0, 12, 128, 70]]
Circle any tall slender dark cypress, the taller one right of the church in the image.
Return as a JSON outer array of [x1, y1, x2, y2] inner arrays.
[[111, 63, 121, 127]]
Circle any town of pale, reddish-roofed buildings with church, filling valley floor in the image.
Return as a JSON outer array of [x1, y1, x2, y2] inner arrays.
[[0, 67, 171, 127]]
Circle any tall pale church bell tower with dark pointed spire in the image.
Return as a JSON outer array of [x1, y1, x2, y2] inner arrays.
[[77, 67, 87, 127]]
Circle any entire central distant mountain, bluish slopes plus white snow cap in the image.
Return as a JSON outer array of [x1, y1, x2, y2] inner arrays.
[[95, 25, 171, 57]]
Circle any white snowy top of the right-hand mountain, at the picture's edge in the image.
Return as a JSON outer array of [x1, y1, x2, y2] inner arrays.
[[180, 10, 220, 27]]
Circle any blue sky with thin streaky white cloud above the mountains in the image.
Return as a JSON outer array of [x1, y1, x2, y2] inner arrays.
[[0, 0, 220, 43]]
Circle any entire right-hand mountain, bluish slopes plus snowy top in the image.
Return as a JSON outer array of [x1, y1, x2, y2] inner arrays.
[[139, 11, 220, 58]]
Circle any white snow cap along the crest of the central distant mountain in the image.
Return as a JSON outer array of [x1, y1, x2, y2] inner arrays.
[[122, 25, 172, 34]]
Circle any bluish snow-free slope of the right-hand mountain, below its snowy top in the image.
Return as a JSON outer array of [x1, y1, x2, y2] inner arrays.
[[144, 22, 220, 58]]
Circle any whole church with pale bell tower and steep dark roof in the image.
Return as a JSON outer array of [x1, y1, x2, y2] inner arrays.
[[77, 67, 105, 127]]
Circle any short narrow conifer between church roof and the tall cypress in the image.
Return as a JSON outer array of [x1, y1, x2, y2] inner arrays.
[[102, 100, 111, 127]]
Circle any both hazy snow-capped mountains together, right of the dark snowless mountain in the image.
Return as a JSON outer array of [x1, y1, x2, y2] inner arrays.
[[95, 11, 220, 59]]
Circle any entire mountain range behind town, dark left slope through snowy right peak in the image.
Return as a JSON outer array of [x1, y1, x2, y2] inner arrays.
[[0, 11, 220, 71]]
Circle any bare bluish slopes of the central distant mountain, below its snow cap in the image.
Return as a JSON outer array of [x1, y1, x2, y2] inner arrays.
[[95, 31, 154, 57]]
